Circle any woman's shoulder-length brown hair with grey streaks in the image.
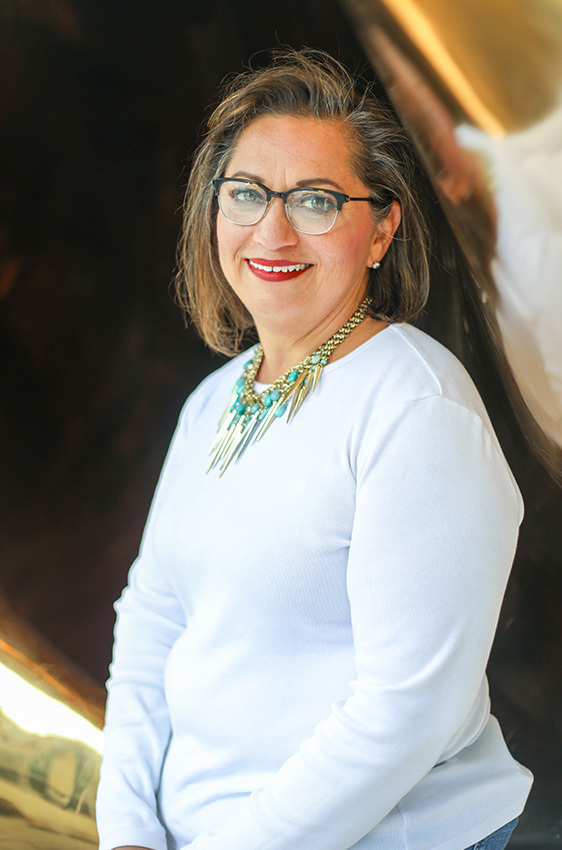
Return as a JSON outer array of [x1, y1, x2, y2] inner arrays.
[[176, 49, 429, 355]]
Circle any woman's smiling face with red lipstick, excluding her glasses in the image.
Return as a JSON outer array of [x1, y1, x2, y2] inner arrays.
[[217, 115, 399, 341]]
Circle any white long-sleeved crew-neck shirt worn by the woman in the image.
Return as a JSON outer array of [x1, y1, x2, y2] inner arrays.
[[98, 325, 531, 850]]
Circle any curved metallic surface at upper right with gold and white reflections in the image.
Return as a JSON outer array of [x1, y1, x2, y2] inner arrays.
[[347, 0, 562, 477]]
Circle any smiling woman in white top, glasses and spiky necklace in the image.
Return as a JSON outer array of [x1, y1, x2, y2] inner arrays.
[[98, 51, 531, 850]]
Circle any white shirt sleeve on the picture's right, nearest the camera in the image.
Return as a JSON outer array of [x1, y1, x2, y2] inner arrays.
[[179, 396, 522, 850]]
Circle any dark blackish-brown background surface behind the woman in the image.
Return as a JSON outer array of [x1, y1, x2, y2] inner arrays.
[[0, 0, 562, 850]]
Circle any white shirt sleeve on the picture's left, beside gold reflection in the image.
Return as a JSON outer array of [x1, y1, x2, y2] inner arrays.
[[96, 402, 190, 850]]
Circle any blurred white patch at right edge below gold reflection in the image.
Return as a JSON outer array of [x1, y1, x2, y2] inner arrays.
[[456, 105, 562, 446]]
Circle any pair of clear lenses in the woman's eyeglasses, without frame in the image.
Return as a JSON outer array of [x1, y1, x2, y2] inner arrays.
[[214, 180, 338, 234]]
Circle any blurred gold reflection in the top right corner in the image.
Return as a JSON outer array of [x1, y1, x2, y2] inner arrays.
[[346, 0, 562, 134]]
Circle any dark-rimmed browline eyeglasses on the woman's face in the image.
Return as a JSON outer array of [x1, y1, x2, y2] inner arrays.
[[211, 177, 373, 236]]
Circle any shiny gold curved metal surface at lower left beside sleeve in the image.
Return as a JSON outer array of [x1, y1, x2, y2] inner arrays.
[[0, 598, 104, 850]]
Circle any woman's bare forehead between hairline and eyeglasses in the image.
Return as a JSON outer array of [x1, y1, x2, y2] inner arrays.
[[226, 115, 357, 188]]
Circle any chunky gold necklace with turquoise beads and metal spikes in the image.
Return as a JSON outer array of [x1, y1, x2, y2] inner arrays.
[[207, 296, 371, 475]]
